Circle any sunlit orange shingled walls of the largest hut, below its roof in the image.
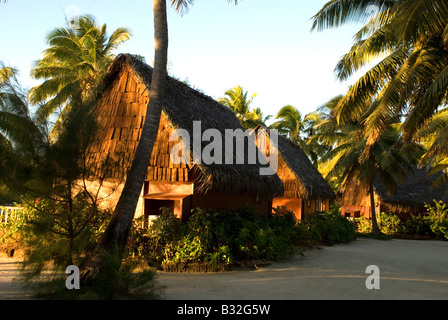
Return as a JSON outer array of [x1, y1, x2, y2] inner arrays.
[[90, 67, 272, 220]]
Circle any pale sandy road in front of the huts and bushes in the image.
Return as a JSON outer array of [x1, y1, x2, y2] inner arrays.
[[0, 239, 448, 300]]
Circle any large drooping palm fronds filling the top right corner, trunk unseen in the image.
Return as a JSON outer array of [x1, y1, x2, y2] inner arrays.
[[313, 0, 448, 162]]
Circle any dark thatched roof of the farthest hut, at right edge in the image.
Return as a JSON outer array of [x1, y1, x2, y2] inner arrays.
[[374, 167, 448, 211]]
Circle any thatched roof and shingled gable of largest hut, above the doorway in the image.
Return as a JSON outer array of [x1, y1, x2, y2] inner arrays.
[[92, 54, 283, 195]]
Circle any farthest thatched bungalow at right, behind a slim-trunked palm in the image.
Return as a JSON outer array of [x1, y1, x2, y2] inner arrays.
[[340, 167, 448, 219]]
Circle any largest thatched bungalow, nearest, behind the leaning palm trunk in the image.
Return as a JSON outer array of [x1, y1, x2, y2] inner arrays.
[[90, 54, 283, 220]]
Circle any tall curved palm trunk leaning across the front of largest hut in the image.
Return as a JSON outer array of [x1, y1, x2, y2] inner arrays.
[[81, 0, 168, 281]]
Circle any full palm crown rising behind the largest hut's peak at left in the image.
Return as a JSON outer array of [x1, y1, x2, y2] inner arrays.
[[29, 16, 131, 124]]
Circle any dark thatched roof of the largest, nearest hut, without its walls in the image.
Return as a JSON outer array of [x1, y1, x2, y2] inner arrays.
[[96, 54, 283, 194]]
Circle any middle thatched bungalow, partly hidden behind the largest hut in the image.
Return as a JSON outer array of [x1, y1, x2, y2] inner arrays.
[[254, 126, 336, 219]]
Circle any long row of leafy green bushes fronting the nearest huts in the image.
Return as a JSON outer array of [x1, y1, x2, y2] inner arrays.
[[133, 206, 356, 271]]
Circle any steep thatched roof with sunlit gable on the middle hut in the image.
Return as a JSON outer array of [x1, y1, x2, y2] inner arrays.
[[254, 126, 336, 199]]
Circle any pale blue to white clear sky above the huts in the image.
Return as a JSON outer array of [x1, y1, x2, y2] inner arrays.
[[0, 0, 368, 119]]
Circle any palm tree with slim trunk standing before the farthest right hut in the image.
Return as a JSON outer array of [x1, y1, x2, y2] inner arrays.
[[317, 96, 423, 234]]
